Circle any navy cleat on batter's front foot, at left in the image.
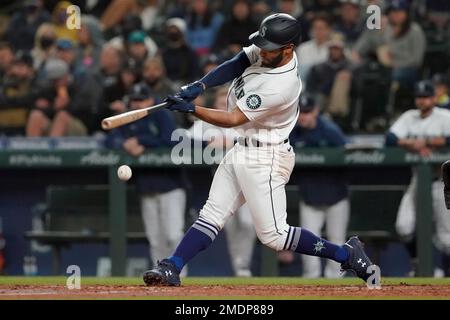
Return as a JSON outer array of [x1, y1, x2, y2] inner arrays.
[[143, 259, 181, 287]]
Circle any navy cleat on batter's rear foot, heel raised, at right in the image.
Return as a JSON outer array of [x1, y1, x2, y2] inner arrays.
[[341, 237, 373, 281]]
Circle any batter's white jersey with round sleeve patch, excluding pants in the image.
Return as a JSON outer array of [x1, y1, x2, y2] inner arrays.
[[227, 45, 302, 143]]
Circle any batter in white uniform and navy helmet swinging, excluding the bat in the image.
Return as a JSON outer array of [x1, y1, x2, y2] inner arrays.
[[143, 14, 372, 286]]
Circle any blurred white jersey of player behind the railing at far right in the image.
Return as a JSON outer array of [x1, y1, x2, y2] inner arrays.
[[390, 107, 450, 139]]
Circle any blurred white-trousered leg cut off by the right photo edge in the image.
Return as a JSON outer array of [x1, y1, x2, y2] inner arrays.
[[432, 181, 450, 276]]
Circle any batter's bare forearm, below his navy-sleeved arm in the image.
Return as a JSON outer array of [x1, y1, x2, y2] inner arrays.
[[194, 106, 250, 128]]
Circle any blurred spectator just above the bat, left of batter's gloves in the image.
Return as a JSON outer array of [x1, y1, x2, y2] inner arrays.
[[142, 57, 175, 100]]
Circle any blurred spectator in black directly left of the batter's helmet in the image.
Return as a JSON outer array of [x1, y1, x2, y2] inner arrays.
[[214, 0, 258, 56]]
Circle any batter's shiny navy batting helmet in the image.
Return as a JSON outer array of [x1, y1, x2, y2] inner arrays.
[[249, 13, 300, 51]]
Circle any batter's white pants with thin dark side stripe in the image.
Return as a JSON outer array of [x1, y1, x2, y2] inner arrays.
[[200, 143, 295, 251]]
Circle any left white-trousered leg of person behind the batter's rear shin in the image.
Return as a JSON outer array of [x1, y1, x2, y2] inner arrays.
[[300, 201, 325, 278]]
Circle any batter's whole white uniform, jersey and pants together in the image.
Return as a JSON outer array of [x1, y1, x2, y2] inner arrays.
[[199, 46, 302, 251]]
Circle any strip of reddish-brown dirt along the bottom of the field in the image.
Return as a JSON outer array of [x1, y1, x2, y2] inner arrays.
[[0, 284, 450, 299]]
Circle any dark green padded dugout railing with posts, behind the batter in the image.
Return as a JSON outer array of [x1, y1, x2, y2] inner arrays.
[[0, 148, 450, 276]]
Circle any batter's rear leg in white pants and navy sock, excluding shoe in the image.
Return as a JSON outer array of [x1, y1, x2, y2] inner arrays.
[[235, 146, 348, 262]]
